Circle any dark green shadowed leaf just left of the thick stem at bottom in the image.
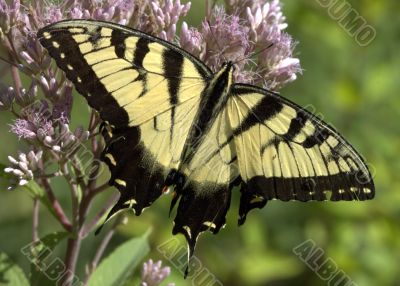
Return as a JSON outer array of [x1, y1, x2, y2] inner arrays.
[[21, 232, 69, 286]]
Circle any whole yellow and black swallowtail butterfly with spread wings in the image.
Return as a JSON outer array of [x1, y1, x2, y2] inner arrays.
[[38, 20, 375, 268]]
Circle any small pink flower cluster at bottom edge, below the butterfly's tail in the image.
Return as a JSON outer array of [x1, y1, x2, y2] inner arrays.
[[140, 259, 175, 286]]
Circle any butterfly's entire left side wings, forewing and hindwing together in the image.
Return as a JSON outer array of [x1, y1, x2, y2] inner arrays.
[[38, 20, 211, 219]]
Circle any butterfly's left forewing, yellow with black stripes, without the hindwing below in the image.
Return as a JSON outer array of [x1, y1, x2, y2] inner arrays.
[[38, 20, 210, 126]]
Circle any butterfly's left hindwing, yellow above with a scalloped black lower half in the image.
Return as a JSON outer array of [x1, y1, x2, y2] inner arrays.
[[102, 98, 198, 216]]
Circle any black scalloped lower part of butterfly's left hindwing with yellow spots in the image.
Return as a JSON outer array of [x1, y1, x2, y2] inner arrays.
[[101, 124, 166, 220]]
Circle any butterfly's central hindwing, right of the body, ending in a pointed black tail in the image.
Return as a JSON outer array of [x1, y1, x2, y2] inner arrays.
[[173, 107, 239, 253]]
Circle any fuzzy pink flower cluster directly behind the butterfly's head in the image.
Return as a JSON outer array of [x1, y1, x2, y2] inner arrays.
[[180, 0, 301, 90]]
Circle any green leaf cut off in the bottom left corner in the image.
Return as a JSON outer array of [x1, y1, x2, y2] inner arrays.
[[0, 252, 29, 286]]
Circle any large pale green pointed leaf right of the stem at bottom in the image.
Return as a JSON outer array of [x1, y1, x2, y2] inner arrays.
[[88, 232, 150, 286]]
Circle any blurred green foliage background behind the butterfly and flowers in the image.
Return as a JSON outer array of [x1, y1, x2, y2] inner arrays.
[[0, 0, 400, 286]]
